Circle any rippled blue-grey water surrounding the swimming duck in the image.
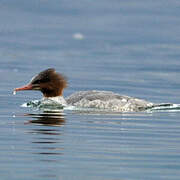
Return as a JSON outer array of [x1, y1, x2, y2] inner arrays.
[[0, 0, 180, 180]]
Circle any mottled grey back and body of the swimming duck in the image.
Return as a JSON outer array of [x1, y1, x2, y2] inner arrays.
[[66, 90, 153, 112]]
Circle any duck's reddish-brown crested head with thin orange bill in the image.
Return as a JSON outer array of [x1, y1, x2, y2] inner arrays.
[[14, 69, 67, 97]]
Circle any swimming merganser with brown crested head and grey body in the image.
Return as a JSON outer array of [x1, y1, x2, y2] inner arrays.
[[14, 68, 154, 112]]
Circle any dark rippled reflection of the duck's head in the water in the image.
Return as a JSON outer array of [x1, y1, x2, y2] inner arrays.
[[24, 112, 65, 162]]
